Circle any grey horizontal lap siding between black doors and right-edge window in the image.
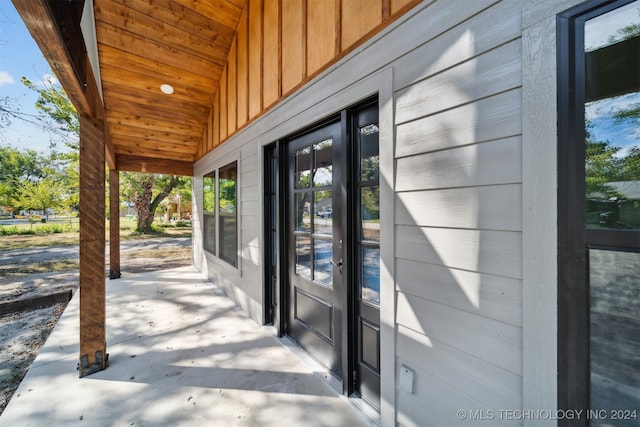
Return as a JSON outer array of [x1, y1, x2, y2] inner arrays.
[[394, 1, 522, 425]]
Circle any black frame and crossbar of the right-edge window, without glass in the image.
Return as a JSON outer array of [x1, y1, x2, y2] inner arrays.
[[556, 0, 640, 426]]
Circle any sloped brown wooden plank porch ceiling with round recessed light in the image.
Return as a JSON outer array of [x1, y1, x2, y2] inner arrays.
[[94, 0, 246, 170]]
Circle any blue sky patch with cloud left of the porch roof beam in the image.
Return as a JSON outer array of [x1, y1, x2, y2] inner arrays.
[[0, 0, 63, 152]]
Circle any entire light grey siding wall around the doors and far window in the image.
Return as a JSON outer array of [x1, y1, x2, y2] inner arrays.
[[194, 0, 572, 427]]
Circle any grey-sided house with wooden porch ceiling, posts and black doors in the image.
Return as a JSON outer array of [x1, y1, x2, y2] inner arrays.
[[13, 0, 640, 426]]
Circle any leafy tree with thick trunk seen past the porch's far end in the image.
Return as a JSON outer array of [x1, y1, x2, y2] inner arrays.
[[120, 172, 188, 234]]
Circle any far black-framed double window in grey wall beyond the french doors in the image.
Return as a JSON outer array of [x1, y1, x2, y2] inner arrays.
[[203, 162, 238, 267]]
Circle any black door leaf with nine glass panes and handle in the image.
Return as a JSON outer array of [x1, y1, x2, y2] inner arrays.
[[286, 121, 346, 375]]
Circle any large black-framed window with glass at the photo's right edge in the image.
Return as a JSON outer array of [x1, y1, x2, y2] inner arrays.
[[558, 0, 640, 427]]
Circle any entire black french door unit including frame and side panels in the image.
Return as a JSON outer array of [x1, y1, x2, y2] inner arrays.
[[264, 100, 380, 408]]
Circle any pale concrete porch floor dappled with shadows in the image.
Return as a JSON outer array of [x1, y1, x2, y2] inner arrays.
[[0, 267, 375, 427]]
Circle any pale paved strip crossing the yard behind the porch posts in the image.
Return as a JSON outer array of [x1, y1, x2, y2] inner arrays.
[[0, 237, 191, 266]]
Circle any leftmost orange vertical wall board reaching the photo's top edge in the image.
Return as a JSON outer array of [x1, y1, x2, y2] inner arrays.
[[249, 0, 262, 119]]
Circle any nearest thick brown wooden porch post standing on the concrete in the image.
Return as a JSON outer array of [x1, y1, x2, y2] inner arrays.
[[79, 116, 107, 377]]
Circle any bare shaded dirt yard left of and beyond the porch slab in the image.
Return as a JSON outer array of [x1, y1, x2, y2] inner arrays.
[[0, 237, 191, 414]]
